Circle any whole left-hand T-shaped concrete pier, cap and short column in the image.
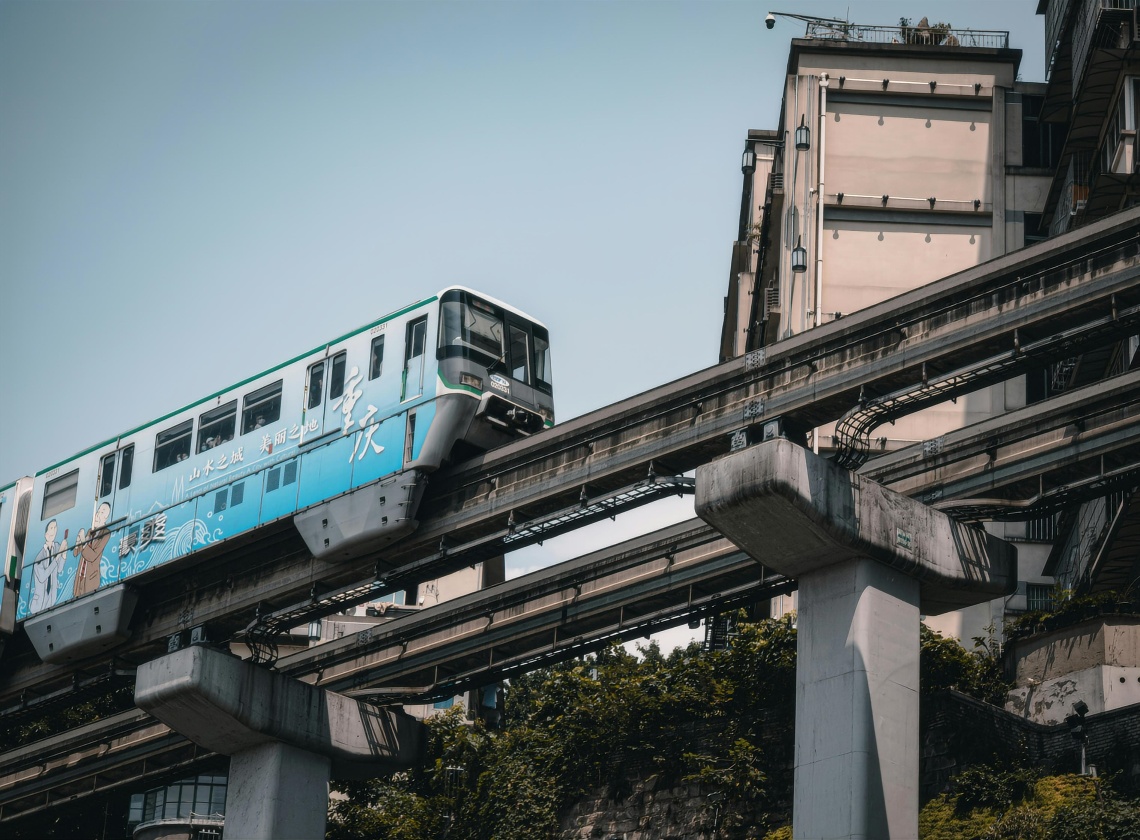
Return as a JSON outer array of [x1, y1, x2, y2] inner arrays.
[[135, 647, 424, 840]]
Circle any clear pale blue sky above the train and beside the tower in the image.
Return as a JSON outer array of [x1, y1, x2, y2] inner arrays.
[[0, 0, 1044, 484]]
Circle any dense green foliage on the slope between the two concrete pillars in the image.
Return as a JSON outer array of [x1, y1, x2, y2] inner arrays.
[[328, 617, 796, 840]]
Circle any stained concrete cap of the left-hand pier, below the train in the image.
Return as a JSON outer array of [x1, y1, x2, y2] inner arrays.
[[135, 646, 424, 778]]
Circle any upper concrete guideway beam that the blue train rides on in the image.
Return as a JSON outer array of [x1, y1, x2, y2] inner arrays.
[[0, 207, 1140, 720]]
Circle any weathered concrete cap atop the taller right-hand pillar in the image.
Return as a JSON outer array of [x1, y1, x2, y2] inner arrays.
[[697, 439, 1017, 615]]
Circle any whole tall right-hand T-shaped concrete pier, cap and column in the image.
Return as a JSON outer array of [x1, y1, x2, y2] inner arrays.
[[697, 440, 1017, 840]]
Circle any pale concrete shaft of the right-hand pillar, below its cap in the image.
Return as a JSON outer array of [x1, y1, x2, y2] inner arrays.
[[792, 557, 919, 838]]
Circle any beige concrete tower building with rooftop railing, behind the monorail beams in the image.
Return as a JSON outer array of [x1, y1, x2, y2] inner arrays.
[[720, 18, 1062, 639]]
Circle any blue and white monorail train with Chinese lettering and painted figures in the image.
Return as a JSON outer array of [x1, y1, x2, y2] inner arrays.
[[0, 286, 554, 662]]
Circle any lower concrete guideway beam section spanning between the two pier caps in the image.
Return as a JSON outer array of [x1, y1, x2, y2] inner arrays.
[[277, 519, 795, 700]]
